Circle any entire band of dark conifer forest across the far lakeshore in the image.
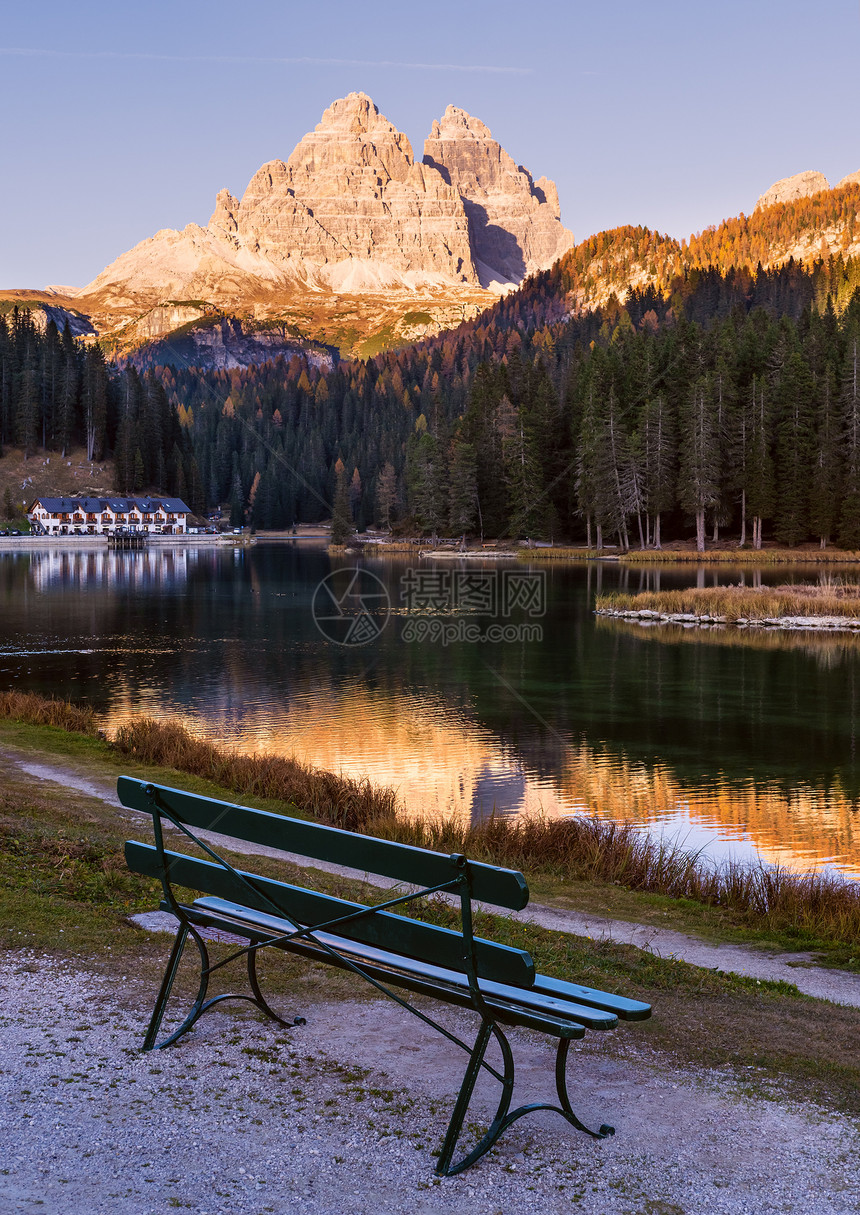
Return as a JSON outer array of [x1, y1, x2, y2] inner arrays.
[[0, 256, 860, 548]]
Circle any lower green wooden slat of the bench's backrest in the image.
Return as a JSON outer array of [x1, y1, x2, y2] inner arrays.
[[125, 840, 534, 987]]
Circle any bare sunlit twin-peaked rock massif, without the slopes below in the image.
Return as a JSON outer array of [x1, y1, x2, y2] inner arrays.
[[80, 92, 572, 305]]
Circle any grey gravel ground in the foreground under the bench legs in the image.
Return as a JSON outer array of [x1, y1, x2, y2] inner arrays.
[[0, 953, 860, 1215]]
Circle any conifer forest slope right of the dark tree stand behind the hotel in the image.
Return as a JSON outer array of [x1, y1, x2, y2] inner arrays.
[[157, 267, 860, 547]]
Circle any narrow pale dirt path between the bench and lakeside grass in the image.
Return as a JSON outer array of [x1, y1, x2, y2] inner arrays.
[[6, 744, 860, 1008]]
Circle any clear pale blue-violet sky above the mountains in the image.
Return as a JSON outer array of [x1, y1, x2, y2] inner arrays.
[[0, 0, 860, 287]]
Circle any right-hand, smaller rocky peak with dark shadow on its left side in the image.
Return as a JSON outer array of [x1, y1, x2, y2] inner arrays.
[[424, 106, 573, 283]]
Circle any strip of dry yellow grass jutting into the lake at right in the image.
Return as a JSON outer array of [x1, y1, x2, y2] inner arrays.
[[594, 581, 860, 623]]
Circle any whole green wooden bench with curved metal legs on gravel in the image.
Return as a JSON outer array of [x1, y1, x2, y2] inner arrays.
[[117, 776, 651, 1176]]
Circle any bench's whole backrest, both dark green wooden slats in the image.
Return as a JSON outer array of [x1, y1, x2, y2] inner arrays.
[[117, 776, 534, 987]]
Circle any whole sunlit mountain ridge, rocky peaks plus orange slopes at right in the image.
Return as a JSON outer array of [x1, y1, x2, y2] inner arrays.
[[0, 104, 860, 361]]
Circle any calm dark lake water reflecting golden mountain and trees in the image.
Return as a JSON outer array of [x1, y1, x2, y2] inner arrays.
[[0, 543, 860, 876]]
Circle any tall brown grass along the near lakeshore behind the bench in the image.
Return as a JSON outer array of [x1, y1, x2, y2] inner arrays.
[[0, 693, 860, 968]]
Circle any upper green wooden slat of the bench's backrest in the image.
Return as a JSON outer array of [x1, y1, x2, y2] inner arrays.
[[117, 776, 528, 911]]
